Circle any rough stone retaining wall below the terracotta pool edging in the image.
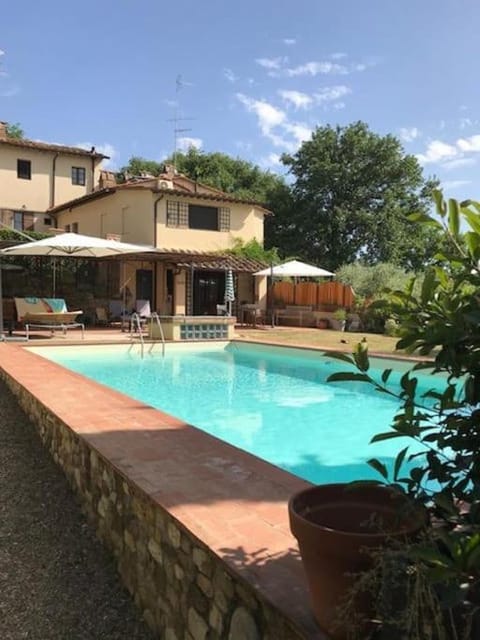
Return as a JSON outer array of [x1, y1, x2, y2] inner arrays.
[[0, 369, 310, 640]]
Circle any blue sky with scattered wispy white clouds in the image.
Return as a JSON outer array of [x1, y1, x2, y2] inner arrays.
[[0, 0, 480, 199]]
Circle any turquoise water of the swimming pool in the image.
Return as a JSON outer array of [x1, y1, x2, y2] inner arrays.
[[33, 343, 441, 483]]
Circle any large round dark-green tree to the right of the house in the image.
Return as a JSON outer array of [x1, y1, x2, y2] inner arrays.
[[267, 122, 439, 270]]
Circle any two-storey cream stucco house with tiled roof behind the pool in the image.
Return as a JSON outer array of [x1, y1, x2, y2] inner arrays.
[[48, 167, 270, 315]]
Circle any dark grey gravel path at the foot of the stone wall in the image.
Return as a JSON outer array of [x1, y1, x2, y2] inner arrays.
[[0, 381, 155, 640]]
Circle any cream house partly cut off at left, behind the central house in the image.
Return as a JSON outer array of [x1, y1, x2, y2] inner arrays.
[[0, 122, 106, 232]]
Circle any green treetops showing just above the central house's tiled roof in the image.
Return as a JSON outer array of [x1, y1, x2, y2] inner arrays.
[[118, 147, 284, 205]]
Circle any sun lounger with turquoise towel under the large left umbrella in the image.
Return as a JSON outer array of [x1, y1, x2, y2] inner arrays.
[[14, 297, 85, 340]]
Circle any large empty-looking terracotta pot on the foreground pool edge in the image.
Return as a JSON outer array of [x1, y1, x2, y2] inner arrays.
[[288, 484, 426, 640]]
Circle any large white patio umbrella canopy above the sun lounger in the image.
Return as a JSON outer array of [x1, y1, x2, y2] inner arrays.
[[0, 233, 156, 335]]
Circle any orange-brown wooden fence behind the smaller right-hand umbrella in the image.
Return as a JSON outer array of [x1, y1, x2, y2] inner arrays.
[[273, 281, 354, 309]]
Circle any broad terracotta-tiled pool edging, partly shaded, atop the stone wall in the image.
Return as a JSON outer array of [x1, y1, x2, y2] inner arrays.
[[0, 340, 325, 640]]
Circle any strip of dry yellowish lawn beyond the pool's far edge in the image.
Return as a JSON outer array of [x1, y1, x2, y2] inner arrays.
[[236, 326, 402, 355]]
